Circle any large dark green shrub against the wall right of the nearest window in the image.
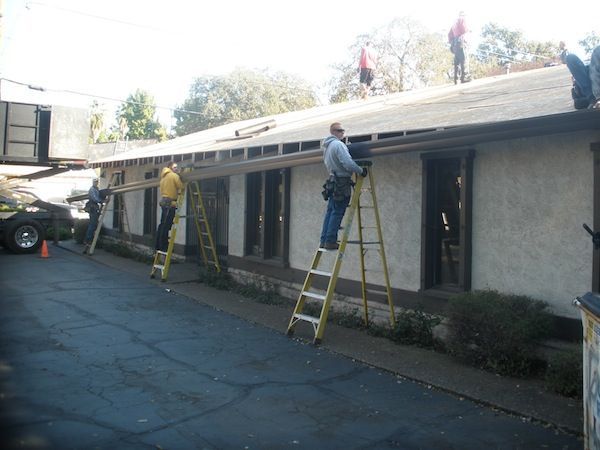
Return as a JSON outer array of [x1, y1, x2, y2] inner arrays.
[[448, 290, 552, 377]]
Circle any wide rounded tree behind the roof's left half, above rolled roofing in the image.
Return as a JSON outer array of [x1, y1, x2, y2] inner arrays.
[[175, 69, 316, 136]]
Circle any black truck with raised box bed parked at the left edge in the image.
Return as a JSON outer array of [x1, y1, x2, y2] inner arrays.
[[0, 100, 89, 253]]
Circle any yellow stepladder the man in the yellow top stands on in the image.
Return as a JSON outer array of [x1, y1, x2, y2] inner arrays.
[[150, 181, 221, 281]]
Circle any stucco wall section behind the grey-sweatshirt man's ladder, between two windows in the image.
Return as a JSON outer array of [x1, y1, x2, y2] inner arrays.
[[288, 154, 421, 291]]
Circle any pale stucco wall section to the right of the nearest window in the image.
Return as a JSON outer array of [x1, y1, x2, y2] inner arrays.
[[472, 133, 599, 318]]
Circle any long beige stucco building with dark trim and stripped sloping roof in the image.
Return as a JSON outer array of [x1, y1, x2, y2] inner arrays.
[[91, 66, 600, 337]]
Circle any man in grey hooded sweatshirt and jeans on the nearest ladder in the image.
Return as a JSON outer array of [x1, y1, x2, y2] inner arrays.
[[320, 122, 367, 250]]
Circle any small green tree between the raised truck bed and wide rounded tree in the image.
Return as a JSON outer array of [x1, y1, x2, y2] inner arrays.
[[117, 89, 167, 141]]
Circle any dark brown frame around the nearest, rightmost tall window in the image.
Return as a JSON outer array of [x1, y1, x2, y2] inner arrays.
[[421, 149, 475, 294]]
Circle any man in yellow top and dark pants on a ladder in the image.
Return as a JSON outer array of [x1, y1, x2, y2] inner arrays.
[[156, 161, 183, 252]]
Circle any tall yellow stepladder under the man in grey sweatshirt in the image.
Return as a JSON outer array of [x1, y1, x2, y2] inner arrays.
[[287, 161, 395, 345]]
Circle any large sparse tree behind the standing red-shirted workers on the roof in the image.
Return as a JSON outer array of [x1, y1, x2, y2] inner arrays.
[[329, 17, 452, 103]]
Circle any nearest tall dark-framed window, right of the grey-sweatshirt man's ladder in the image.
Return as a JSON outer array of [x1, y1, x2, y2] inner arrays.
[[421, 152, 473, 291]]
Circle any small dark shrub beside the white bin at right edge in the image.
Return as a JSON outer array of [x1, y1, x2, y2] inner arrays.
[[544, 349, 583, 398]]
